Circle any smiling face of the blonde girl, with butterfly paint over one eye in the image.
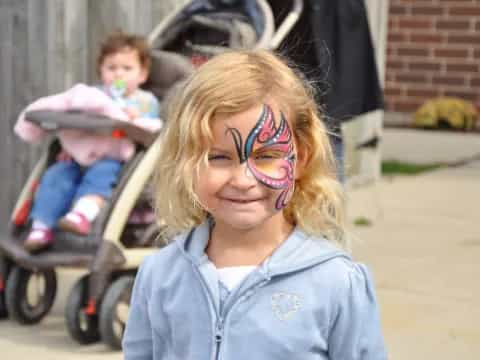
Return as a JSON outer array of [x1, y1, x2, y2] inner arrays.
[[195, 104, 296, 229]]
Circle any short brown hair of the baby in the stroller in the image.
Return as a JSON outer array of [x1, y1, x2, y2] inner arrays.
[[97, 30, 151, 73]]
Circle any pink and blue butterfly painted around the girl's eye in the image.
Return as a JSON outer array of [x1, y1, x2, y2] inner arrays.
[[227, 104, 296, 210]]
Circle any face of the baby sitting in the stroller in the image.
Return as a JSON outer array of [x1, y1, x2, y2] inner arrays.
[[100, 48, 148, 95]]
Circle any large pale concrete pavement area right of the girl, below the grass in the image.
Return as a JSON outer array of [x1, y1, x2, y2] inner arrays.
[[349, 162, 480, 360]]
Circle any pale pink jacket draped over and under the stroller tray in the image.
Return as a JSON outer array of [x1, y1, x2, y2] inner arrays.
[[14, 84, 162, 166]]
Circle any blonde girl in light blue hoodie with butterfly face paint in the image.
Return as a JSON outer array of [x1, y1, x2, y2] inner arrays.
[[123, 51, 386, 360]]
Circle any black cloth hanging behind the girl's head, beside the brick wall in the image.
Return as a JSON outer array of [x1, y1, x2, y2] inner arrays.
[[270, 0, 383, 127]]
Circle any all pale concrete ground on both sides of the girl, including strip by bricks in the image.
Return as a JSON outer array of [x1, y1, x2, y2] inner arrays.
[[0, 129, 480, 360]]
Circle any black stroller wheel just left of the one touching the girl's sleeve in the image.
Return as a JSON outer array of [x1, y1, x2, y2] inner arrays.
[[65, 275, 100, 345]]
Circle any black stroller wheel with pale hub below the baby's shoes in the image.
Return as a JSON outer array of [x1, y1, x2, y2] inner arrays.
[[5, 266, 57, 324]]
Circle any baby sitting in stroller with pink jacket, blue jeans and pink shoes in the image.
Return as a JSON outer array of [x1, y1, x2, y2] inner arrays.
[[14, 32, 162, 253]]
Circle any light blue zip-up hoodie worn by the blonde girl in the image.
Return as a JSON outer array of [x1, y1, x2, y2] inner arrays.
[[123, 224, 387, 360]]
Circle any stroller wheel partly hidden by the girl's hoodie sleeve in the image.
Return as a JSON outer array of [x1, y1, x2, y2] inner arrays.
[[100, 275, 135, 350]]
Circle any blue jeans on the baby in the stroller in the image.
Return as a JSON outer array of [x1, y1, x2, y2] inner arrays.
[[30, 159, 122, 227]]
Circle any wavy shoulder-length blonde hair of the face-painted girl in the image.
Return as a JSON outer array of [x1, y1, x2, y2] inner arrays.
[[155, 50, 345, 245]]
